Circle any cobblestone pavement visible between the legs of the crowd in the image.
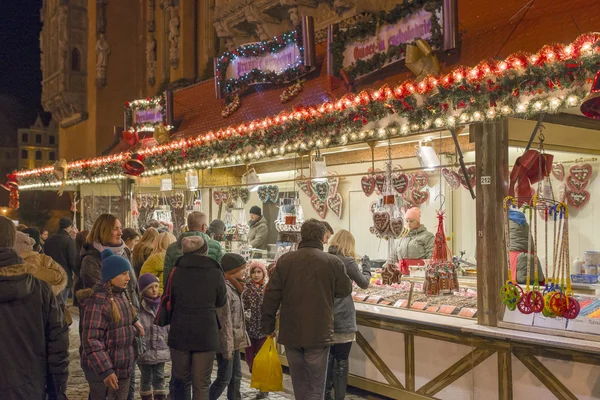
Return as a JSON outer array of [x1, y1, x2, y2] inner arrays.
[[67, 308, 379, 400]]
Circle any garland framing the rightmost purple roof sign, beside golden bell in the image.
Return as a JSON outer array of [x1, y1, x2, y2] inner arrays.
[[330, 0, 443, 81]]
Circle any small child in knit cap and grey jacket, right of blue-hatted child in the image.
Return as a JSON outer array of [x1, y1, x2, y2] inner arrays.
[[137, 273, 171, 400]]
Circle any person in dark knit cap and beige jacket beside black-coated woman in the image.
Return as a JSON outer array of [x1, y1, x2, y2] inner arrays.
[[210, 253, 250, 400]]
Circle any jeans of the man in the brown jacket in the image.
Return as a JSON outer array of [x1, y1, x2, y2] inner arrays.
[[285, 346, 329, 400]]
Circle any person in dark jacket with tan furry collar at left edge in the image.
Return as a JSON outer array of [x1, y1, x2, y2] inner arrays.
[[0, 216, 69, 400]]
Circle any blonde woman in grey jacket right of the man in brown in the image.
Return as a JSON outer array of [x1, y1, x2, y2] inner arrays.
[[325, 229, 371, 400]]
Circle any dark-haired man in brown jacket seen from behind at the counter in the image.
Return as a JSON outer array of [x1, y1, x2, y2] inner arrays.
[[261, 219, 352, 400]]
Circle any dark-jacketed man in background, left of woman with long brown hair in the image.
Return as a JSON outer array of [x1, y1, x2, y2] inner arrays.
[[44, 217, 77, 304]]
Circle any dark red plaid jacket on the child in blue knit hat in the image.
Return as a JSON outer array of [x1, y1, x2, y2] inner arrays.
[[77, 283, 137, 381]]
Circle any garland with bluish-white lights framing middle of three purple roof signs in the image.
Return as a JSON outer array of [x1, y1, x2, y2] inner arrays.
[[216, 27, 306, 95]]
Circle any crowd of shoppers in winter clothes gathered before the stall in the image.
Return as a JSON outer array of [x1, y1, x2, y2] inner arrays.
[[0, 207, 370, 400]]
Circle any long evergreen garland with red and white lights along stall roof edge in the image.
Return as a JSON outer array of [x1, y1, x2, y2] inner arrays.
[[16, 34, 600, 189]]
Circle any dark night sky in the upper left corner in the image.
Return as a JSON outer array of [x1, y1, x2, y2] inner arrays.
[[0, 0, 42, 135]]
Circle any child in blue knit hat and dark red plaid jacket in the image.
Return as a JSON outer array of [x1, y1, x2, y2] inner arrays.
[[77, 249, 139, 400]]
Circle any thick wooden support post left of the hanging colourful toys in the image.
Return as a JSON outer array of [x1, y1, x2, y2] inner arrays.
[[471, 119, 508, 326]]
